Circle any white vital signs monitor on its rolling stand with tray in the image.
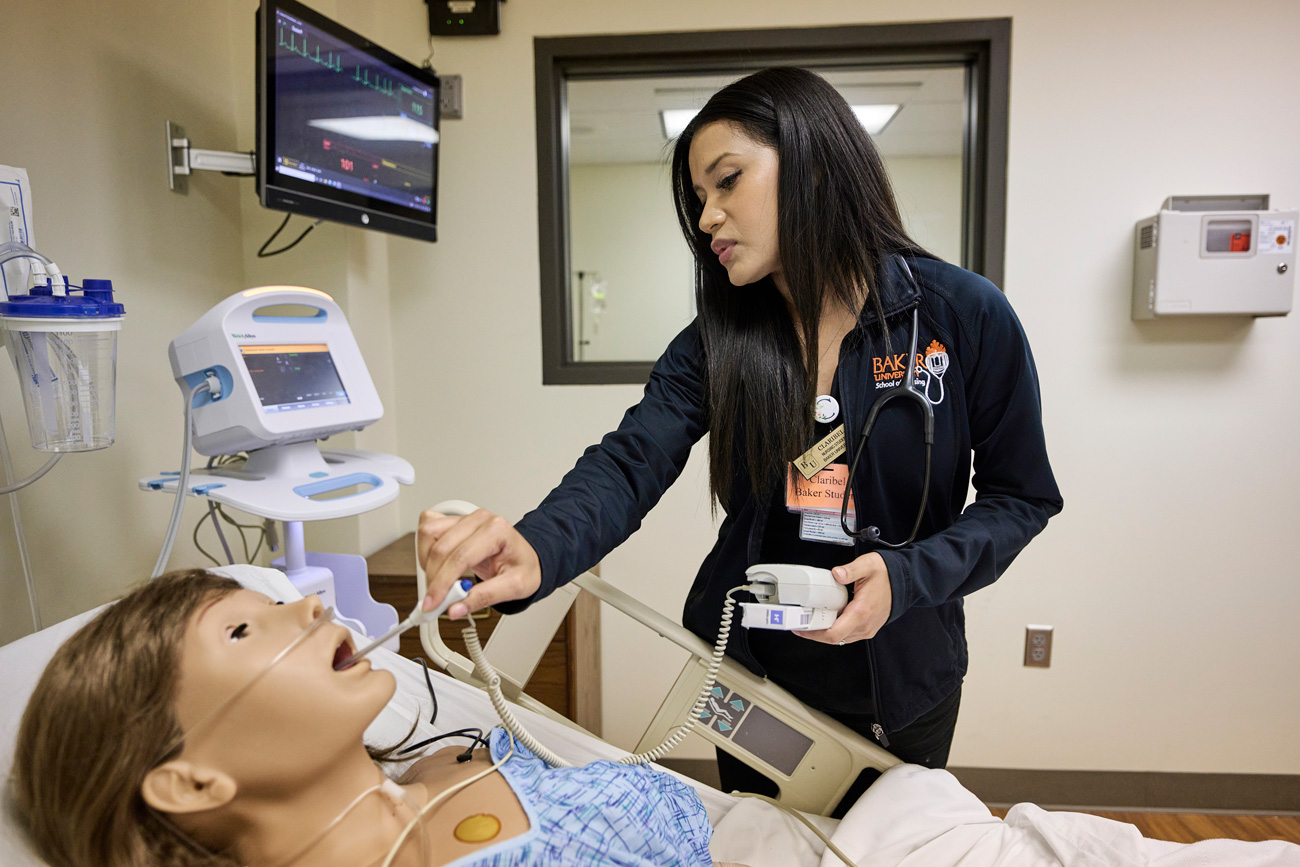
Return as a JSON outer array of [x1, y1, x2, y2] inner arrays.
[[148, 286, 415, 650]]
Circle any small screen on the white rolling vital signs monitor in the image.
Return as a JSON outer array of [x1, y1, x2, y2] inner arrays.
[[239, 343, 351, 412]]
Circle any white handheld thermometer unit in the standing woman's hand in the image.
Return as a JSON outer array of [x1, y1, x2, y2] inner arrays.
[[740, 563, 849, 632]]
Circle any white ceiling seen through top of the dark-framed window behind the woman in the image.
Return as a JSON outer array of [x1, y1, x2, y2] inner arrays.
[[568, 66, 966, 164]]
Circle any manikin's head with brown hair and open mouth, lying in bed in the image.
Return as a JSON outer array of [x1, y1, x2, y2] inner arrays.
[[12, 569, 395, 867]]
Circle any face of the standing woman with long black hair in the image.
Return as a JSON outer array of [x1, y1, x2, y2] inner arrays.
[[688, 121, 783, 286]]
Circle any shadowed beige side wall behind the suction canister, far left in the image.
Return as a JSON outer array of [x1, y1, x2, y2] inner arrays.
[[0, 0, 243, 642]]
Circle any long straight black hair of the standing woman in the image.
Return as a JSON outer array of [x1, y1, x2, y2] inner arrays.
[[672, 66, 930, 507]]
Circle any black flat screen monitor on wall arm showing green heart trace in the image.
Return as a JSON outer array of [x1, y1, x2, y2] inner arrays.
[[256, 0, 439, 240]]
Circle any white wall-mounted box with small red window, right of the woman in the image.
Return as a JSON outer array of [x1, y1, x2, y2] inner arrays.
[[1132, 195, 1300, 320]]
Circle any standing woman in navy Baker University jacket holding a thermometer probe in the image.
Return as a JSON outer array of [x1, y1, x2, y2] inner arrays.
[[419, 68, 1062, 790]]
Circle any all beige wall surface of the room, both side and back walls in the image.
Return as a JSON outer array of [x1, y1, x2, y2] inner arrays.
[[0, 0, 1300, 773]]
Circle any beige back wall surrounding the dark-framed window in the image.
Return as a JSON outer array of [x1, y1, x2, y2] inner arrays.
[[376, 0, 1300, 773]]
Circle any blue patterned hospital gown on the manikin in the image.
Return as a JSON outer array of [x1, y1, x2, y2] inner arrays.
[[449, 728, 714, 867]]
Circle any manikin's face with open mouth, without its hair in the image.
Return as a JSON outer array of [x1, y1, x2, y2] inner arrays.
[[176, 590, 395, 783]]
